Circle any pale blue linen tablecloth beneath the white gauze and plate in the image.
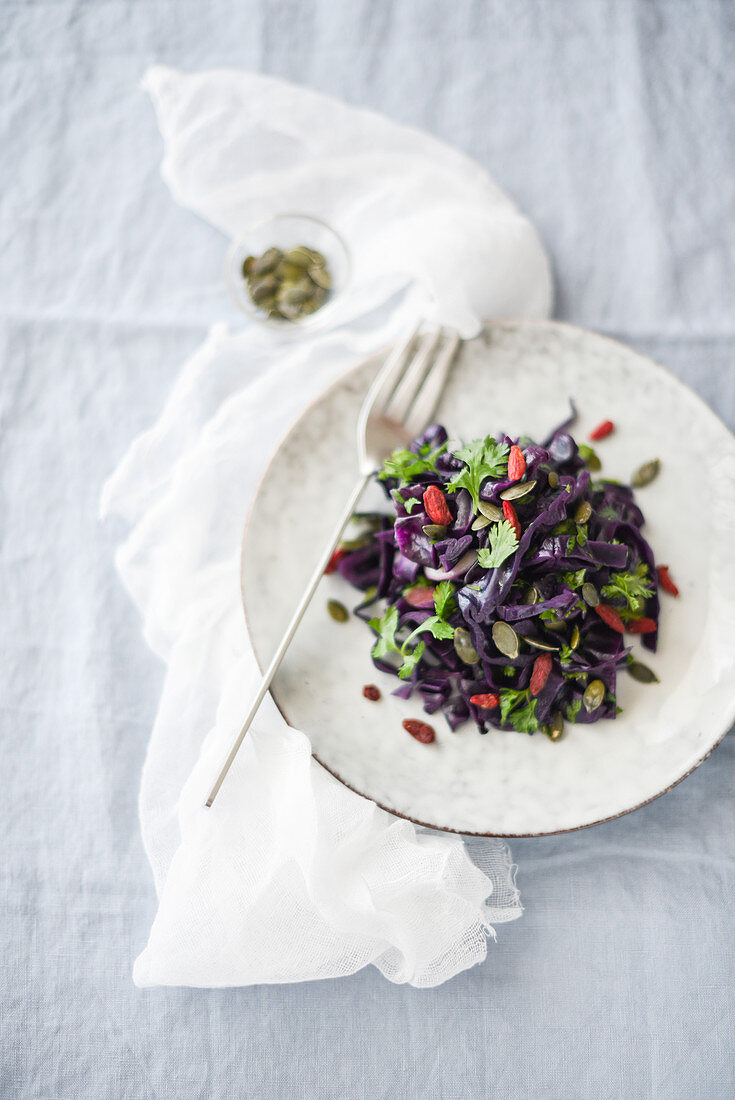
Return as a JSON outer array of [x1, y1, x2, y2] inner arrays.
[[0, 0, 735, 1100]]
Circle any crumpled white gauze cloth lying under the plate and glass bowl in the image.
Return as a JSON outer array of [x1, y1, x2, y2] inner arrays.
[[102, 67, 551, 987]]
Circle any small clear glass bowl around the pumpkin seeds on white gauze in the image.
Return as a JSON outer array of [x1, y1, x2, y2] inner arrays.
[[226, 213, 350, 332]]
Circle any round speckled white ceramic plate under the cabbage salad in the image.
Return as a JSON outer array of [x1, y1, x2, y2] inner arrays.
[[242, 321, 735, 836]]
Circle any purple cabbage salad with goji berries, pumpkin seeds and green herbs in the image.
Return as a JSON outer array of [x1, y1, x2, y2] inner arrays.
[[336, 420, 672, 740]]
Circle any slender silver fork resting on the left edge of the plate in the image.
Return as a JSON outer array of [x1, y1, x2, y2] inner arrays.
[[206, 325, 460, 806]]
